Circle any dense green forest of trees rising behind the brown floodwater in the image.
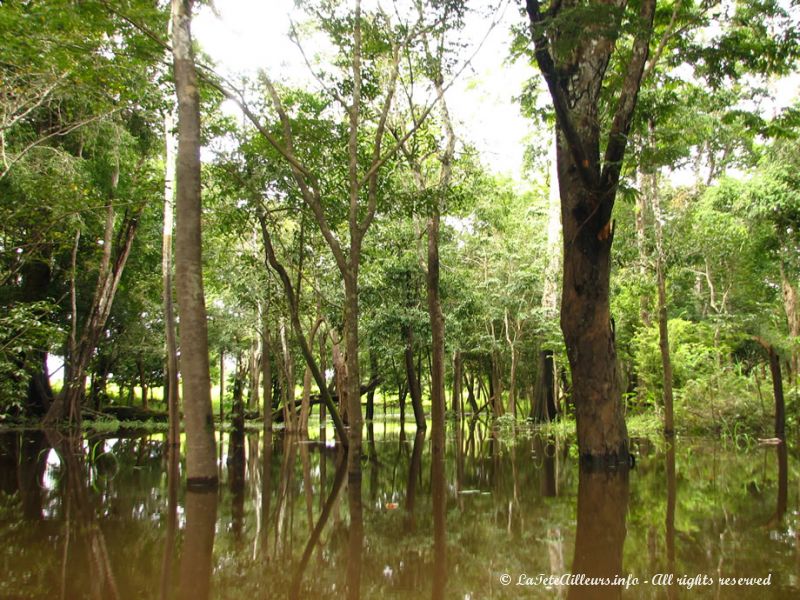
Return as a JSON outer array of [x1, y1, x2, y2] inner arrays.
[[0, 0, 800, 455]]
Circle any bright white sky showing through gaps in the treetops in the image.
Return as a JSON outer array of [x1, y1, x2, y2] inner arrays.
[[192, 0, 535, 181]]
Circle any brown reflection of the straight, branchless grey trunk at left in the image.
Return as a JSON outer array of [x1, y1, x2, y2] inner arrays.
[[178, 490, 217, 600]]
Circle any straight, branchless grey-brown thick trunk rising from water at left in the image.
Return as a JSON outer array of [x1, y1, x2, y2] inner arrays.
[[172, 0, 217, 488]]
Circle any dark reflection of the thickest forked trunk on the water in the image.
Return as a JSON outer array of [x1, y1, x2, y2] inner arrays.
[[567, 467, 628, 598]]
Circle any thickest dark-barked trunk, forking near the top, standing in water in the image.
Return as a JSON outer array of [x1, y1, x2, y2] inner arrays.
[[526, 0, 655, 464]]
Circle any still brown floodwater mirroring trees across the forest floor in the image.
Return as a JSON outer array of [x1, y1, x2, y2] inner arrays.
[[0, 422, 800, 599]]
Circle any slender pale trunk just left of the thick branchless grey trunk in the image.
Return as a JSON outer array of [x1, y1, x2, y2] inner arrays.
[[161, 106, 178, 448]]
